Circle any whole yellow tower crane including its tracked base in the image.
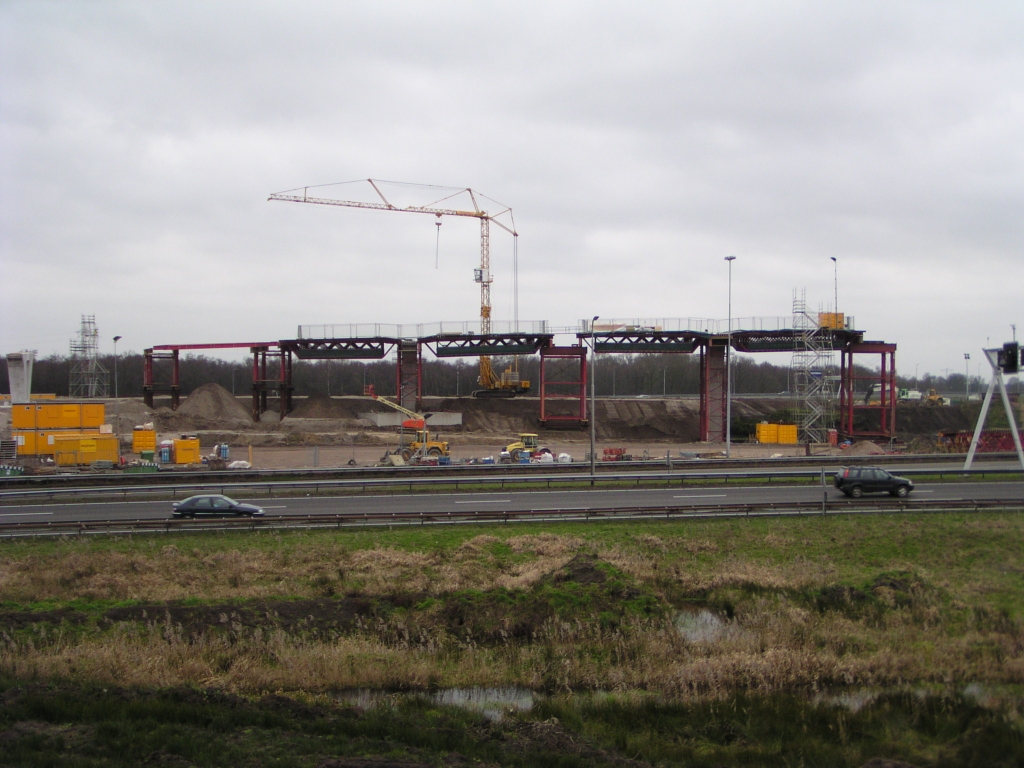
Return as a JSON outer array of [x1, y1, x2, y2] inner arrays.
[[268, 178, 529, 397]]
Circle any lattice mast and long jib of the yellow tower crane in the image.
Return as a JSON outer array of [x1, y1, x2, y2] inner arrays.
[[268, 178, 519, 390]]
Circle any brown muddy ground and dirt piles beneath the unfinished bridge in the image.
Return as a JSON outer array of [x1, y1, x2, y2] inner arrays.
[[0, 384, 973, 469]]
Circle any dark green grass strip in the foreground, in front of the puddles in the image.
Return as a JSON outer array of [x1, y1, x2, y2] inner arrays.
[[0, 679, 1024, 768]]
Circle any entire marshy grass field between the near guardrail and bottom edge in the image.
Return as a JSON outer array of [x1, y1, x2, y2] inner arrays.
[[0, 513, 1024, 766]]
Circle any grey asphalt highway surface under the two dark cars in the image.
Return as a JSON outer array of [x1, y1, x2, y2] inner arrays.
[[0, 481, 1024, 525]]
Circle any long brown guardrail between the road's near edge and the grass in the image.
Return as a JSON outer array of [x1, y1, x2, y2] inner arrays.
[[0, 500, 1024, 539]]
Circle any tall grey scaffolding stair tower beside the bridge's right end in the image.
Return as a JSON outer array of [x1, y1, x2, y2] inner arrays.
[[790, 289, 836, 442]]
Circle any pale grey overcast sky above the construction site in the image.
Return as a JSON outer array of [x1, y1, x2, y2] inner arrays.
[[0, 0, 1024, 375]]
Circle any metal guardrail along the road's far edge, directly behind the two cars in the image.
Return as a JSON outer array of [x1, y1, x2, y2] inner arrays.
[[0, 467, 1022, 506]]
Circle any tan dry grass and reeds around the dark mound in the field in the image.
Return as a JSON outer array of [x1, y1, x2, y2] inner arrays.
[[0, 515, 1024, 696]]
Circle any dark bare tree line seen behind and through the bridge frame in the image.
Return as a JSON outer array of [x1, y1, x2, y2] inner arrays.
[[0, 353, 1017, 397]]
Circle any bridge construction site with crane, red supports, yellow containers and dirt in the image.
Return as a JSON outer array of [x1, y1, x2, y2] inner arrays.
[[0, 179, 991, 473]]
